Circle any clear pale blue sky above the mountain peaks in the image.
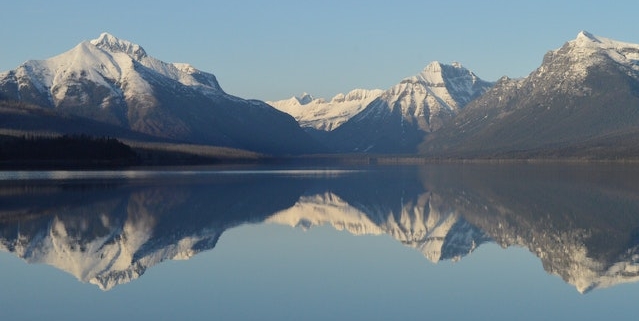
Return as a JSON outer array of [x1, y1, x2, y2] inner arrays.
[[0, 0, 639, 100]]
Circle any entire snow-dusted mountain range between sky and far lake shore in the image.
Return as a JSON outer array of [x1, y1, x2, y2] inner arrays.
[[0, 32, 639, 158]]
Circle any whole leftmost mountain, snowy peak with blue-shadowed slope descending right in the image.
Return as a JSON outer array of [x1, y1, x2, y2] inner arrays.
[[0, 33, 315, 153]]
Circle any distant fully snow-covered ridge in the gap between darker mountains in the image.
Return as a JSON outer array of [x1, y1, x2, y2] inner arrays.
[[267, 89, 383, 131]]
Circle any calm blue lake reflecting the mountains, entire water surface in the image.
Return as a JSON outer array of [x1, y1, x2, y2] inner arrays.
[[0, 164, 639, 320]]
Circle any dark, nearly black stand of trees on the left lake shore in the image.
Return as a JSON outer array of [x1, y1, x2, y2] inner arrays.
[[0, 135, 137, 162]]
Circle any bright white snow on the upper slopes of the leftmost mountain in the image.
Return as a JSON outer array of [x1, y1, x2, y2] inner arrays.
[[2, 33, 222, 106]]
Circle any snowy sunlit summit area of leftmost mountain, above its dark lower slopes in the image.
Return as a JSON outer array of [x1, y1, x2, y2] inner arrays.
[[0, 33, 224, 108]]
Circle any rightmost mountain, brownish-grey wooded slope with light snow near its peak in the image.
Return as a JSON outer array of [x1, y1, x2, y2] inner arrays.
[[421, 31, 639, 157]]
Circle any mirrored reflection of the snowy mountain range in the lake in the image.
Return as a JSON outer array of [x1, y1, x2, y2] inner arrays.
[[0, 165, 639, 293]]
